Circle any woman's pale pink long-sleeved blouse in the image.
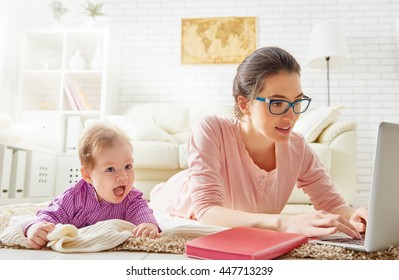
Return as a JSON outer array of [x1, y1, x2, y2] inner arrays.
[[155, 116, 345, 221]]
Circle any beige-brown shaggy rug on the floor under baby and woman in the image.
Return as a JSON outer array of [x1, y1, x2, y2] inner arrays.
[[0, 203, 399, 260]]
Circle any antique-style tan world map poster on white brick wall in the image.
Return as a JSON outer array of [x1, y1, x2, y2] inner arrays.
[[181, 17, 256, 64]]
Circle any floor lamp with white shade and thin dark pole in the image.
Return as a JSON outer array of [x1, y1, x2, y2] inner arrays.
[[308, 22, 349, 106]]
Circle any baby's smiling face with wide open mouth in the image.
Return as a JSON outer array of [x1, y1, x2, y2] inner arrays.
[[90, 141, 134, 204]]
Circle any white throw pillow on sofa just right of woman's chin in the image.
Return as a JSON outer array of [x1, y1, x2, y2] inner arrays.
[[294, 106, 343, 142]]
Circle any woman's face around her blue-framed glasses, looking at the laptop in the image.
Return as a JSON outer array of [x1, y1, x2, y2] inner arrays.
[[249, 72, 303, 142]]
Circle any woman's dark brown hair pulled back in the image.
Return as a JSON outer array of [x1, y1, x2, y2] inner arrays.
[[233, 47, 301, 118]]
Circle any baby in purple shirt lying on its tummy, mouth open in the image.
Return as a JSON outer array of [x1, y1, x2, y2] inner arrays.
[[25, 124, 160, 249]]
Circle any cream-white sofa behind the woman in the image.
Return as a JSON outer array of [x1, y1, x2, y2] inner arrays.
[[107, 103, 356, 206]]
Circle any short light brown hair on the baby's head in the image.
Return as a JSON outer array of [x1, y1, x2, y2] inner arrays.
[[79, 123, 133, 170]]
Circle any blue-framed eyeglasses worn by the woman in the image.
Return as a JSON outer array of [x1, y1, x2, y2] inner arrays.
[[255, 95, 312, 115]]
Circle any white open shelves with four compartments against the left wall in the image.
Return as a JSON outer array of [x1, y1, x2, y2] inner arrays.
[[17, 28, 111, 152]]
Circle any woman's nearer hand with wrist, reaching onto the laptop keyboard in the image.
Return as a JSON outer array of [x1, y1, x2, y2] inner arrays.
[[281, 211, 361, 238]]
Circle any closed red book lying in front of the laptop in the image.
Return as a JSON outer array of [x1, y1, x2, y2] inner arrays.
[[186, 227, 308, 260]]
